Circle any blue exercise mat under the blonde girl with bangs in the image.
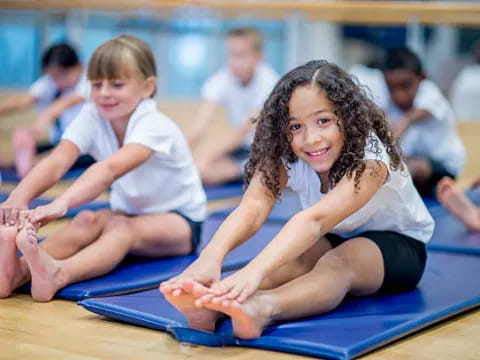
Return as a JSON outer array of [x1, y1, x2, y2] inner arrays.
[[19, 218, 280, 300]]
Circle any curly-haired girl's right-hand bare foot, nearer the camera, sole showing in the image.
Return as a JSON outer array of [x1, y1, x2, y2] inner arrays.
[[204, 291, 275, 339]]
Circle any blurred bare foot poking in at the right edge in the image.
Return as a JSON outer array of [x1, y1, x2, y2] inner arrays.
[[437, 178, 480, 231]]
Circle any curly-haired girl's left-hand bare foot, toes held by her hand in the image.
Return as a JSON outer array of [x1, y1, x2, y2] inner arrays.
[[160, 280, 220, 332]]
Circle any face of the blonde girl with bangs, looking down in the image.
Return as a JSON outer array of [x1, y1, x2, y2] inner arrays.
[[91, 70, 155, 122]]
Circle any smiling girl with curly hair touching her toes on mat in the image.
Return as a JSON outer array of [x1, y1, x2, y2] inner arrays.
[[160, 61, 434, 339]]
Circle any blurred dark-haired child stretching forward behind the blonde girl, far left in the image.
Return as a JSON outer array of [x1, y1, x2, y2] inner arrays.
[[0, 44, 89, 178]]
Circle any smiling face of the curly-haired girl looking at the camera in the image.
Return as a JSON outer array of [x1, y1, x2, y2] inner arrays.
[[288, 86, 344, 183]]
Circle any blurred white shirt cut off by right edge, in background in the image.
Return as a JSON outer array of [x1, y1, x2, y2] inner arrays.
[[450, 64, 480, 120]]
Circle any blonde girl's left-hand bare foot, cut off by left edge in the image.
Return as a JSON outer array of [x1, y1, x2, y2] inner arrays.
[[0, 225, 28, 298]]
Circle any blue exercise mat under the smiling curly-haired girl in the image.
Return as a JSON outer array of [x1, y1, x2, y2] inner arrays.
[[79, 252, 480, 359]]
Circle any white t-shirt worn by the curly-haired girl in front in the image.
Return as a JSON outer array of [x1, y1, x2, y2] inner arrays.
[[287, 135, 434, 243]]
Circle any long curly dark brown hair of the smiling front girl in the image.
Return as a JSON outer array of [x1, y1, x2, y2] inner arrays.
[[245, 60, 404, 198]]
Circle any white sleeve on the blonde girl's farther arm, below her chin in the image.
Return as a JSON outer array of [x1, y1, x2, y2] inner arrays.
[[62, 103, 98, 154]]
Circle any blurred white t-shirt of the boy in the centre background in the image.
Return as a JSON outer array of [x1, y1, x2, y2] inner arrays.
[[202, 64, 278, 147]]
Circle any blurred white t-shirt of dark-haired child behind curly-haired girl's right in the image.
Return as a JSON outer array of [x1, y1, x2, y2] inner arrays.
[[384, 79, 465, 175]]
